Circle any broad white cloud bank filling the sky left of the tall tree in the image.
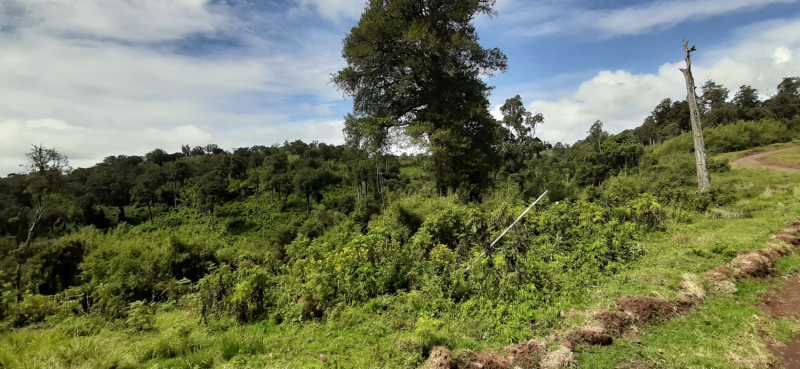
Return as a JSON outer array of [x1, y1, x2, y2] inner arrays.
[[0, 0, 350, 175]]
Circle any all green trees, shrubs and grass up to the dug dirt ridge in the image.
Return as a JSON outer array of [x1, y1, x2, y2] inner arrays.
[[0, 0, 800, 368]]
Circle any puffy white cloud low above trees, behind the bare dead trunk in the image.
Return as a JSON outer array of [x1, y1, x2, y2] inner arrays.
[[529, 19, 800, 142]]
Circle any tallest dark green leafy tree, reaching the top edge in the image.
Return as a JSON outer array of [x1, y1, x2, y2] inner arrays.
[[333, 0, 507, 194]]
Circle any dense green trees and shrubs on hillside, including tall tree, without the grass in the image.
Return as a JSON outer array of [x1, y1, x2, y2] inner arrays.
[[0, 1, 800, 367]]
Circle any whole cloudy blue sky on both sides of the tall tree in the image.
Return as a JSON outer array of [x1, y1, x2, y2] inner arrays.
[[0, 0, 800, 175]]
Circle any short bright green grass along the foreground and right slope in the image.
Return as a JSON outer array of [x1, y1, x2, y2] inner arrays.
[[0, 150, 800, 369]]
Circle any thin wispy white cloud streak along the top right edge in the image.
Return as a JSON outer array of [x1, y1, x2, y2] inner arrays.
[[501, 0, 797, 37]]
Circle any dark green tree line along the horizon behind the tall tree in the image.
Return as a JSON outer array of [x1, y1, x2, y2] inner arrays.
[[0, 73, 800, 243]]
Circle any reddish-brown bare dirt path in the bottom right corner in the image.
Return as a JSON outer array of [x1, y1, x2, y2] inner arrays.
[[759, 275, 800, 369]]
